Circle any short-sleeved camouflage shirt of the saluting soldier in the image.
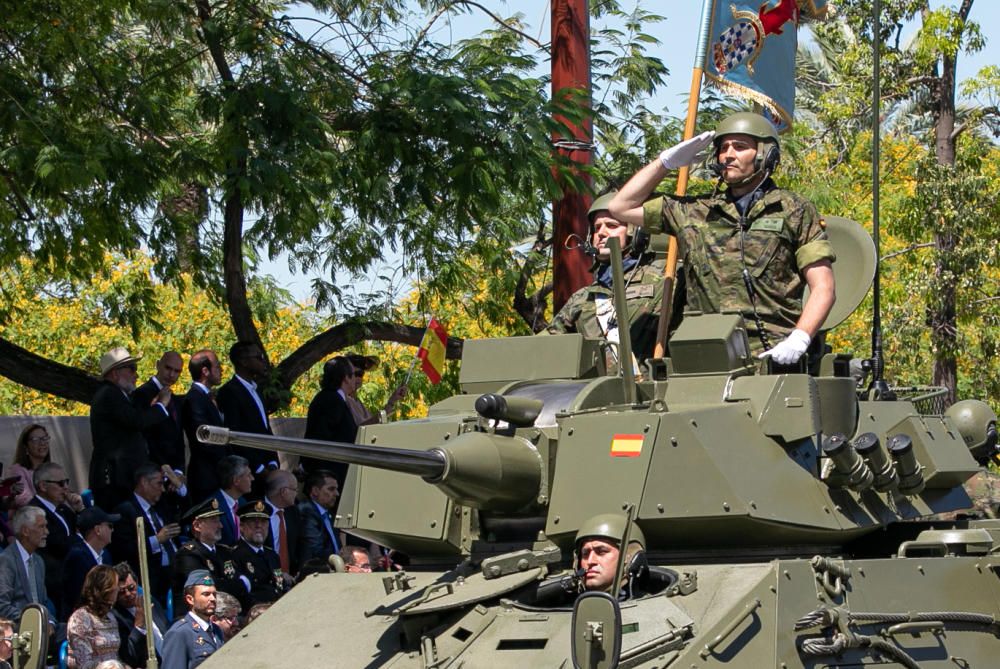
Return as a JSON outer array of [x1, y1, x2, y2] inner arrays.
[[643, 180, 836, 351]]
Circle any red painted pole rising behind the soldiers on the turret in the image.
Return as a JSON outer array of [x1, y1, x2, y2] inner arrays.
[[552, 0, 593, 311]]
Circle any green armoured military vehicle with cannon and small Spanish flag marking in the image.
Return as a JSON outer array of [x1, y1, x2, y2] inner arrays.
[[9, 219, 1000, 669]]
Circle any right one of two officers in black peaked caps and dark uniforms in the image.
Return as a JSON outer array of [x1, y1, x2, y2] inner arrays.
[[233, 500, 292, 604]]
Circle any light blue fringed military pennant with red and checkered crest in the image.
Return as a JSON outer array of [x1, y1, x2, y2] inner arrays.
[[704, 0, 826, 130]]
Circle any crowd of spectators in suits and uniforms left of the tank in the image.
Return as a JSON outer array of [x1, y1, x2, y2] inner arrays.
[[0, 342, 401, 669]]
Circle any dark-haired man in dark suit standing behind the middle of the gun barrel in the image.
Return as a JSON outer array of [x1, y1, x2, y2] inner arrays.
[[299, 356, 358, 478]]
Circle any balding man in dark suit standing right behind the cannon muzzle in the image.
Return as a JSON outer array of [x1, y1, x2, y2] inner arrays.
[[181, 349, 233, 503]]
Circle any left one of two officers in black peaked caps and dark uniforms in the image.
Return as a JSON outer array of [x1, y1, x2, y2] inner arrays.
[[173, 497, 250, 612]]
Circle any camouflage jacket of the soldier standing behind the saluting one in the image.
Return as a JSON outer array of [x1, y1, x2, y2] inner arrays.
[[546, 254, 664, 360]]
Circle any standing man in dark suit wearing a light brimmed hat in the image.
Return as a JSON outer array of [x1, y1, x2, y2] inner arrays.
[[90, 346, 171, 509]]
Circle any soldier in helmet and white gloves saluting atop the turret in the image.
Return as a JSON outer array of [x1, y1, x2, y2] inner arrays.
[[607, 112, 836, 365]]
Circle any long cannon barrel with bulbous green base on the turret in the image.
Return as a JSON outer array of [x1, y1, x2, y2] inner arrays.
[[197, 425, 542, 510]]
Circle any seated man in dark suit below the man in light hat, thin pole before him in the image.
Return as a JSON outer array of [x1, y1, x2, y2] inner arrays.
[[111, 462, 181, 603]]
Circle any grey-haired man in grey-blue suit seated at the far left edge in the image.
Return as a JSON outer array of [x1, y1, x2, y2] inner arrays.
[[0, 506, 49, 620]]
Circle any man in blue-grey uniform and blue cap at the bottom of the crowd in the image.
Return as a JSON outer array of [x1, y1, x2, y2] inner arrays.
[[160, 569, 224, 669]]
